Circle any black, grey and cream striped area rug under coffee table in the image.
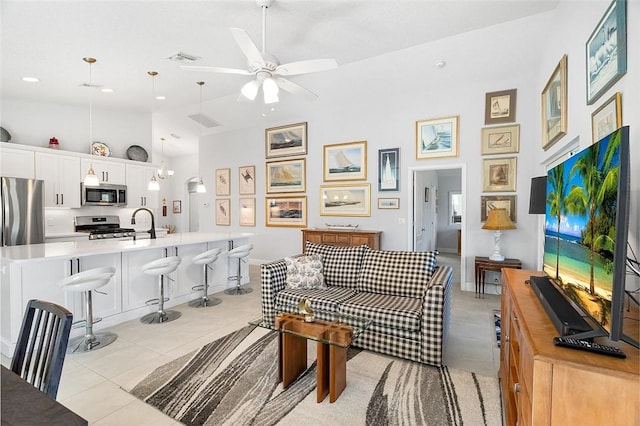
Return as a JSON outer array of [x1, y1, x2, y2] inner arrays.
[[131, 326, 502, 426]]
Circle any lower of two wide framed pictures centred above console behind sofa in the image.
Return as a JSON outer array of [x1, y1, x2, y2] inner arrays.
[[320, 183, 371, 216]]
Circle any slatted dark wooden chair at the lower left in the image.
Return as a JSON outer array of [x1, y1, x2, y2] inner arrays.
[[11, 299, 73, 399]]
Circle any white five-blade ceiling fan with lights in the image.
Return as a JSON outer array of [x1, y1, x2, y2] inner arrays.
[[180, 0, 338, 104]]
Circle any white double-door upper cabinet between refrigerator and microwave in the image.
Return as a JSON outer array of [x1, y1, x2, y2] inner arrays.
[[35, 152, 82, 208]]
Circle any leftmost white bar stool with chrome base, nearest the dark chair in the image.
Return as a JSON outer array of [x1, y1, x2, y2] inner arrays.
[[58, 266, 118, 354]]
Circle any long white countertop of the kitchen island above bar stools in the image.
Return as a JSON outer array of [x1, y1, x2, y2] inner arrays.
[[0, 232, 253, 262]]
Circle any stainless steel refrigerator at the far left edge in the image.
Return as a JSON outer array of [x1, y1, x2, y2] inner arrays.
[[0, 177, 44, 246]]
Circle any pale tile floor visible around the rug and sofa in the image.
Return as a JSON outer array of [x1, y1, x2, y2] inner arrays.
[[2, 254, 500, 426]]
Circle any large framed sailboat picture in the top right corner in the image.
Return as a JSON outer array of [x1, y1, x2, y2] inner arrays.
[[586, 0, 627, 105]]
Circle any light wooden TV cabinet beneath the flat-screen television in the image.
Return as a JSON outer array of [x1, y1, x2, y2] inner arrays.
[[500, 269, 640, 426]]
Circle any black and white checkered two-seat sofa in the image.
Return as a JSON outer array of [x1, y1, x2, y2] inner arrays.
[[261, 241, 453, 365]]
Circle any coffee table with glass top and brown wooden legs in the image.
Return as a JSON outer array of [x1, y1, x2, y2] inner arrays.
[[250, 312, 371, 402]]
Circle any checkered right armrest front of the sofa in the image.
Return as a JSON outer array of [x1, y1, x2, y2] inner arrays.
[[421, 265, 453, 365]]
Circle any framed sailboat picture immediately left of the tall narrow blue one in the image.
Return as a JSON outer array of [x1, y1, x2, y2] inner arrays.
[[322, 141, 367, 182]]
